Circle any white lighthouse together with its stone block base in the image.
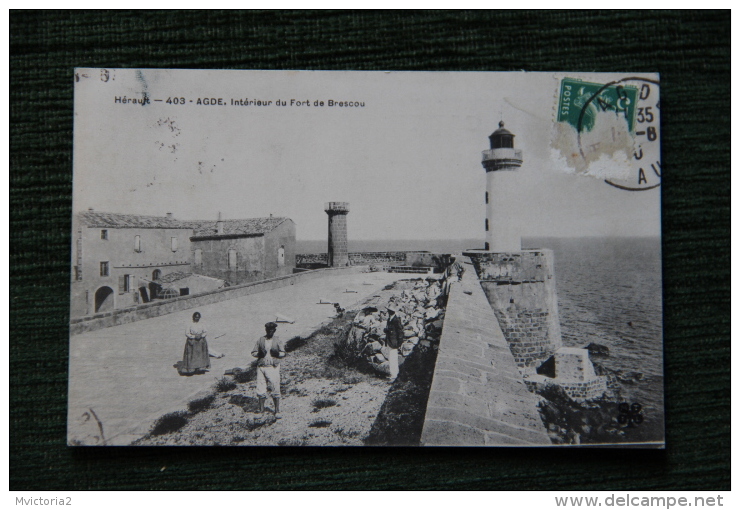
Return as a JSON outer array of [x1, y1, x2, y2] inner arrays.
[[472, 121, 564, 375]]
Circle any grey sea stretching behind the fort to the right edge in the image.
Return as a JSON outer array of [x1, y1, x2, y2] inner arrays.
[[296, 237, 664, 441]]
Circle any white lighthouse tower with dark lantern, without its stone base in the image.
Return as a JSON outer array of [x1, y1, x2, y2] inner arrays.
[[483, 121, 523, 253]]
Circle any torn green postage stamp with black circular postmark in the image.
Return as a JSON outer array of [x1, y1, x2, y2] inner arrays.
[[551, 75, 662, 191]]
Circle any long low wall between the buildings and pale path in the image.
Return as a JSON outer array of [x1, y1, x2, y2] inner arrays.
[[69, 267, 360, 335]]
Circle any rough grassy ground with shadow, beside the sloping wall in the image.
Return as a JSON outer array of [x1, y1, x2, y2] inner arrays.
[[134, 280, 437, 446]]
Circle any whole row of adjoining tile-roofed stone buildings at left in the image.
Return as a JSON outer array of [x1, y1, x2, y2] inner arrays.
[[70, 210, 295, 317]]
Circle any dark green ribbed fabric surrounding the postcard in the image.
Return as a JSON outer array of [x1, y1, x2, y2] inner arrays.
[[9, 11, 730, 490]]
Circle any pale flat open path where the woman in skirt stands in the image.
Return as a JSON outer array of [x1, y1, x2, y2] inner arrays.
[[68, 273, 404, 445]]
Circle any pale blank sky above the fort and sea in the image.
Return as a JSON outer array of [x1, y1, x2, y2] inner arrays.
[[73, 69, 660, 240]]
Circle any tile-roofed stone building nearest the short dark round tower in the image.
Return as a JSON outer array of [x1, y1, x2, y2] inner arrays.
[[190, 216, 295, 285]]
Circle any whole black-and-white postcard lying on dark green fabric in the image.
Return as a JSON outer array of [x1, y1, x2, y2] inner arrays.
[[68, 68, 664, 448]]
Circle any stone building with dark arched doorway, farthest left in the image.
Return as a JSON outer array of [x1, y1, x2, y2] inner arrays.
[[70, 211, 193, 317]]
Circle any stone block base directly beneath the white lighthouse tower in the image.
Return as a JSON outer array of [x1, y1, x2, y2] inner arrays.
[[469, 249, 562, 369]]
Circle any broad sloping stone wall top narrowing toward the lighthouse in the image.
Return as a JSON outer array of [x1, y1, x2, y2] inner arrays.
[[421, 258, 551, 446]]
